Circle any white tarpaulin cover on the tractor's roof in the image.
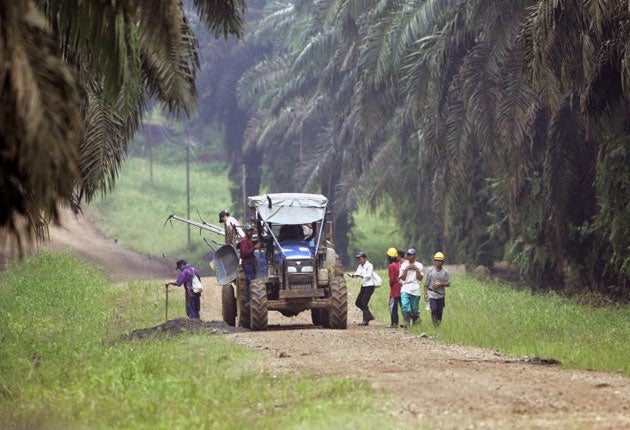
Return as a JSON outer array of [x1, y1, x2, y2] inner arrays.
[[247, 193, 328, 224]]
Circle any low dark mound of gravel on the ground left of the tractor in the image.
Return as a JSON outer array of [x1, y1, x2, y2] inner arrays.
[[123, 318, 249, 341]]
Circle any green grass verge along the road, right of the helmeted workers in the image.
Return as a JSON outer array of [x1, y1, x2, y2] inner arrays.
[[360, 271, 630, 376]]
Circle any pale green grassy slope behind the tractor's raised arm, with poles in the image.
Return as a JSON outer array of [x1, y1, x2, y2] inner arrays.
[[90, 158, 230, 274]]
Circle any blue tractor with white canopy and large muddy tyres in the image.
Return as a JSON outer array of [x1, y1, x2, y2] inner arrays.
[[171, 193, 348, 330]]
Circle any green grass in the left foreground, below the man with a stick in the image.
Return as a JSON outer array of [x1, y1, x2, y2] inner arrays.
[[0, 254, 396, 429]]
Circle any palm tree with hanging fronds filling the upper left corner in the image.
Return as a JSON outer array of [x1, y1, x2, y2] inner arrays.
[[0, 0, 244, 249]]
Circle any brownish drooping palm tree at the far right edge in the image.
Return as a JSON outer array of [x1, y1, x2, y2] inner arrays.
[[522, 1, 630, 288]]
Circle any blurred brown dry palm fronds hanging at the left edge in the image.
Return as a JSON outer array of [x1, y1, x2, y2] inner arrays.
[[0, 1, 82, 243]]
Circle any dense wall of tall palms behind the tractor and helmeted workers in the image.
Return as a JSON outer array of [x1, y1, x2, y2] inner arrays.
[[205, 0, 630, 298]]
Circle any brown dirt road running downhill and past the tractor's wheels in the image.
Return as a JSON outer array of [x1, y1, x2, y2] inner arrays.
[[3, 210, 630, 429]]
